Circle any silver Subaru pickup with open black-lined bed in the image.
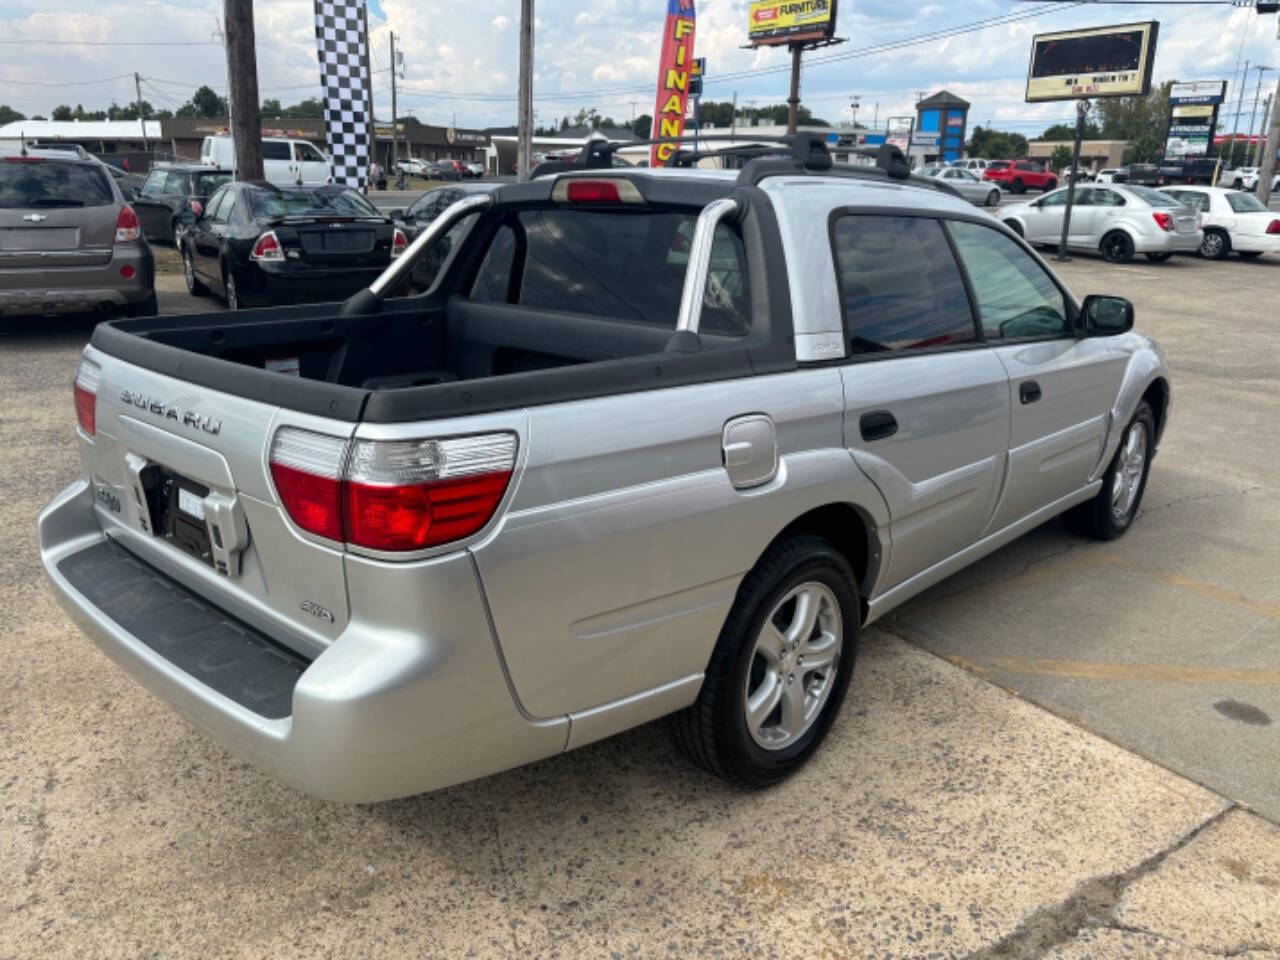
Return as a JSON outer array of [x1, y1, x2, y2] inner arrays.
[[38, 137, 1170, 801]]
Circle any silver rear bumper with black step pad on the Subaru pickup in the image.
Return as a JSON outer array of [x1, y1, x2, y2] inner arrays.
[[38, 479, 568, 803]]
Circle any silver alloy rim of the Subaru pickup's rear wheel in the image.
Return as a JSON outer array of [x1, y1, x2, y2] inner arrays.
[[744, 580, 844, 750]]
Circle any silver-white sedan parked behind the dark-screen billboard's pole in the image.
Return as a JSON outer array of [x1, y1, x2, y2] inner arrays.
[[996, 183, 1202, 264]]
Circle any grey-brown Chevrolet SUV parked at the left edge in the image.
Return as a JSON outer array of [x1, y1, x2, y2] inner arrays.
[[0, 146, 156, 316]]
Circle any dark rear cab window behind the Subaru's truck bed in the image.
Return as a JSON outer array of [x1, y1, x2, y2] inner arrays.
[[471, 209, 751, 335]]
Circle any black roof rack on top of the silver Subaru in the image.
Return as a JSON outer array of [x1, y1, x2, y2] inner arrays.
[[532, 131, 960, 196]]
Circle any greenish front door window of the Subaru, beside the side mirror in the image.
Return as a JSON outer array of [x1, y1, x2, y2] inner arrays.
[[947, 220, 1071, 340]]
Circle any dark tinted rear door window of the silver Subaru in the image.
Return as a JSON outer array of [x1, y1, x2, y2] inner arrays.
[[832, 216, 977, 353]]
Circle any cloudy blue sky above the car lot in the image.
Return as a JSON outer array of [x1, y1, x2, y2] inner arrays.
[[0, 0, 1280, 136]]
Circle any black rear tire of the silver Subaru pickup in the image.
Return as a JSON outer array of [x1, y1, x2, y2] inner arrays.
[[668, 534, 860, 787]]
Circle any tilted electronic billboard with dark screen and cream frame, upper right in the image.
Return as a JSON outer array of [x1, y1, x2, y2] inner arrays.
[[1027, 20, 1160, 104]]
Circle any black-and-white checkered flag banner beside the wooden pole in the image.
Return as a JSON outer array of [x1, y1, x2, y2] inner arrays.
[[316, 0, 372, 189]]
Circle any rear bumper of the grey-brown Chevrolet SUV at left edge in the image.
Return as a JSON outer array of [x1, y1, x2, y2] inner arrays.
[[0, 243, 155, 316]]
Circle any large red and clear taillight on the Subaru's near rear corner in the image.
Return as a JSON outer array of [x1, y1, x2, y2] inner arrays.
[[270, 428, 516, 552]]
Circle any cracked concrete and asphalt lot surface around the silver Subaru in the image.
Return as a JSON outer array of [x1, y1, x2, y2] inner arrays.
[[0, 245, 1280, 960]]
